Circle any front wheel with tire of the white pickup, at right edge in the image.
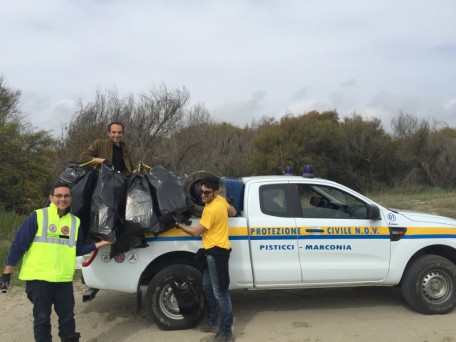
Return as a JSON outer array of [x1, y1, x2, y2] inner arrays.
[[401, 255, 456, 315]]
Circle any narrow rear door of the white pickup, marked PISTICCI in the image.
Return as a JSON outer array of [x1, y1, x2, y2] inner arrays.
[[247, 180, 302, 287]]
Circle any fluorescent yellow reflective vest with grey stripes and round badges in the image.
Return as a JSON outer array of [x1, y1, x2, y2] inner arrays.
[[19, 203, 80, 282]]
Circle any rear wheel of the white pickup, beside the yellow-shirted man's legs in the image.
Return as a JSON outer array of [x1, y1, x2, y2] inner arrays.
[[146, 264, 204, 330]]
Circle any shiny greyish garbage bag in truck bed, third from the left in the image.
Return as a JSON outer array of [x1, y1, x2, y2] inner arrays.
[[124, 172, 159, 235]]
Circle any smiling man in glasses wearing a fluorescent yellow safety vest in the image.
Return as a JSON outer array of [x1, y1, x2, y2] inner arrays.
[[0, 183, 112, 342]]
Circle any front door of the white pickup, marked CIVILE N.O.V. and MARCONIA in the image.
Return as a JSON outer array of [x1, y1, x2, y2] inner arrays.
[[296, 184, 390, 283]]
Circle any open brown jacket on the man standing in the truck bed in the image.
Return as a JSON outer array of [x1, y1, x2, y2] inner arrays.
[[79, 138, 134, 176]]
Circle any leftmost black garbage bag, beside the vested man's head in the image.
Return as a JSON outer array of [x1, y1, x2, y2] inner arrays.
[[55, 162, 98, 239]]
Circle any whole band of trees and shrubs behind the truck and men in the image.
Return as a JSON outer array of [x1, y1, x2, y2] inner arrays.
[[0, 76, 456, 214]]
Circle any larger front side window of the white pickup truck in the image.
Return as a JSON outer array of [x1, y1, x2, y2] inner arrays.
[[297, 184, 367, 219]]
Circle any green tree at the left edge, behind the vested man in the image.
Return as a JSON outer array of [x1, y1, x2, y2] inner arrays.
[[0, 77, 54, 214]]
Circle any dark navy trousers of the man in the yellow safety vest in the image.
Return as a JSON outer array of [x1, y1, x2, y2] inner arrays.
[[25, 280, 76, 342]]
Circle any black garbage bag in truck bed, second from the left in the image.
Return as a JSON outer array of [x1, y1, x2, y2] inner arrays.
[[89, 163, 128, 242]]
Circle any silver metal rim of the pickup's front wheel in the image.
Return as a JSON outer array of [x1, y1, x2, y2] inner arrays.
[[421, 270, 452, 304]]
